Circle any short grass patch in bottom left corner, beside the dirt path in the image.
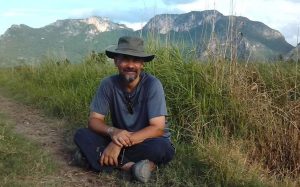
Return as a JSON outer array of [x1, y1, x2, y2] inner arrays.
[[0, 115, 55, 186]]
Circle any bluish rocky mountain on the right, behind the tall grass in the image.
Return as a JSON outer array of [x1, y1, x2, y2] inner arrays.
[[143, 10, 293, 60]]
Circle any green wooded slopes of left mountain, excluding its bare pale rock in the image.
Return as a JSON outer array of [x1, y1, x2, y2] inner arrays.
[[0, 24, 134, 66]]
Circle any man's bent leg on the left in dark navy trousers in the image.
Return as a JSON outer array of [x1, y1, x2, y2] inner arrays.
[[74, 128, 112, 171]]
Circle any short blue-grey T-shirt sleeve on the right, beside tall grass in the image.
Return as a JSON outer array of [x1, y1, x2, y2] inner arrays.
[[147, 79, 167, 119]]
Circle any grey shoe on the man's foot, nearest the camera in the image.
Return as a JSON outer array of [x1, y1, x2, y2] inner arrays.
[[131, 160, 155, 183]]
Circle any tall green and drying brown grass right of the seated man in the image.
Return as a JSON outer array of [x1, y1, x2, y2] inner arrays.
[[149, 45, 300, 181]]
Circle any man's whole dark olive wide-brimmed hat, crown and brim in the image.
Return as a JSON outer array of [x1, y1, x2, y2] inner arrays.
[[105, 36, 155, 62]]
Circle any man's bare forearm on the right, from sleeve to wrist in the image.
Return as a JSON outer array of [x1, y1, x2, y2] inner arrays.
[[130, 116, 166, 145]]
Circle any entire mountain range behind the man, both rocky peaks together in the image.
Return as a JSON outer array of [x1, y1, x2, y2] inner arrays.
[[0, 10, 294, 65]]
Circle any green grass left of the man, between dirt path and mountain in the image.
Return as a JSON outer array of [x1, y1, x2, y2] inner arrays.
[[1, 58, 114, 124]]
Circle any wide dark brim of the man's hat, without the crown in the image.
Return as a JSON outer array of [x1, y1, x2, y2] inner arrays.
[[105, 46, 155, 62]]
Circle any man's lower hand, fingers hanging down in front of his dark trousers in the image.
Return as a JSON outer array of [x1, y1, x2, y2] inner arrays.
[[100, 142, 122, 166]]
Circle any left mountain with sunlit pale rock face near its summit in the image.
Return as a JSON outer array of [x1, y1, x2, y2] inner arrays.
[[0, 17, 133, 63]]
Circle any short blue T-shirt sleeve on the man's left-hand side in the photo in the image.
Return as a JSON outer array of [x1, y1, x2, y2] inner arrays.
[[90, 78, 112, 116]]
